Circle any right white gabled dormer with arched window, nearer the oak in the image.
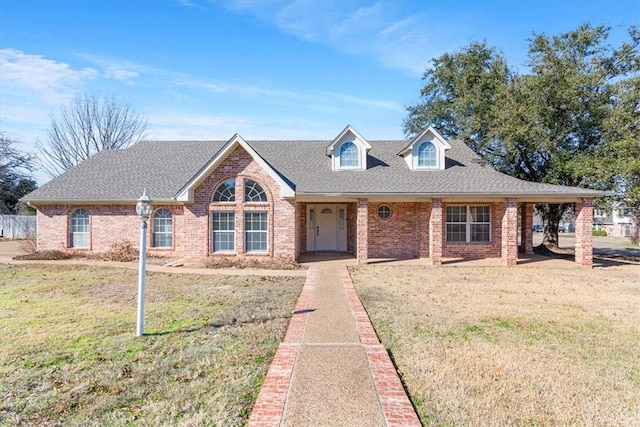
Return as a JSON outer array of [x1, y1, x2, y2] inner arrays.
[[398, 126, 451, 171]]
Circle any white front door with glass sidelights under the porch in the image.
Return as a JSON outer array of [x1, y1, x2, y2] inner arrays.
[[307, 205, 347, 252]]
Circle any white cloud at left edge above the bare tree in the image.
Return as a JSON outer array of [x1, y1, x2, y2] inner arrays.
[[0, 49, 98, 105]]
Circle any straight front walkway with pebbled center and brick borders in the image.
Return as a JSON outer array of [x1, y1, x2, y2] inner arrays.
[[248, 263, 421, 427]]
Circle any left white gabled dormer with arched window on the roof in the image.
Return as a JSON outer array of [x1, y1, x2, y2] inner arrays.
[[327, 125, 371, 171]]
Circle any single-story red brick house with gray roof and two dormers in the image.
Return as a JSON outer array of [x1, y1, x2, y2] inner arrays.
[[23, 126, 602, 266]]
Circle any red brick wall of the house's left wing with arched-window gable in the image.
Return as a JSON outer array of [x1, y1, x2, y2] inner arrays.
[[38, 148, 296, 258]]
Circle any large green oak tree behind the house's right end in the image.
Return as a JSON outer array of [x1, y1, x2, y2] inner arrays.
[[404, 24, 640, 247]]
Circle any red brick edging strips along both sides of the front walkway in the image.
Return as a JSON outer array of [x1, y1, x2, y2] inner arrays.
[[247, 265, 422, 427]]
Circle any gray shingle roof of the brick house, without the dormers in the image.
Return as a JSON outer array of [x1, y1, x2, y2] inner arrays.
[[23, 140, 602, 202]]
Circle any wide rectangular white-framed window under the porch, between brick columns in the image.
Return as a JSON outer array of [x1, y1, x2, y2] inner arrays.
[[446, 206, 491, 243]]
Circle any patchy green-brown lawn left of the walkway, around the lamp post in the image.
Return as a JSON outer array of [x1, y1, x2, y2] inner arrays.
[[0, 265, 303, 426]]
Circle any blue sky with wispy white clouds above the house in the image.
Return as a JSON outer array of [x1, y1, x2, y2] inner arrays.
[[0, 0, 640, 176]]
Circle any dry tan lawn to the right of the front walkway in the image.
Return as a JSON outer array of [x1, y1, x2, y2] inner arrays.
[[351, 266, 640, 425]]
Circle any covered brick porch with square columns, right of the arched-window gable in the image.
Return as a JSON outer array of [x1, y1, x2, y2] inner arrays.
[[296, 198, 593, 267]]
